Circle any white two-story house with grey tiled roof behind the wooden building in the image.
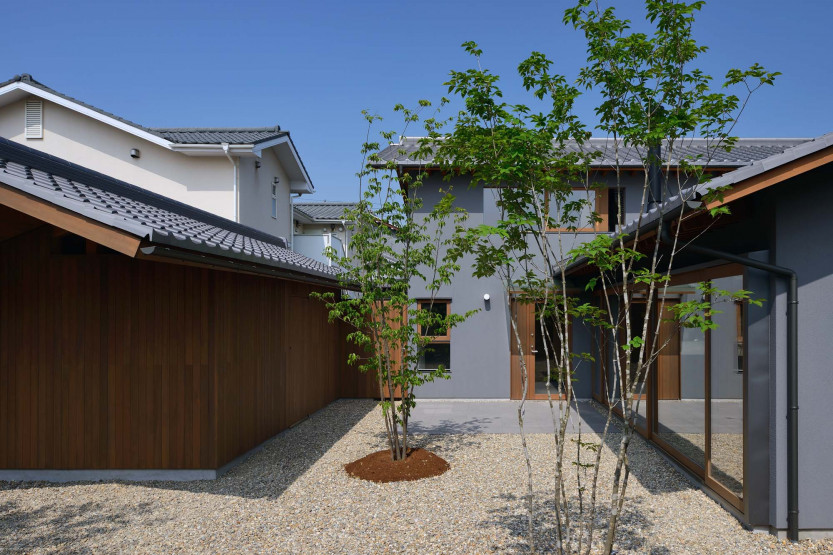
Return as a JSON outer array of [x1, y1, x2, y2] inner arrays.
[[0, 74, 314, 239]]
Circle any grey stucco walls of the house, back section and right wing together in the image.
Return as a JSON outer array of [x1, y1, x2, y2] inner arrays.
[[421, 157, 833, 535]]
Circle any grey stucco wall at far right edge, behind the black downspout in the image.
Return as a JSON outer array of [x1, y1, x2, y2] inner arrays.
[[770, 167, 833, 530]]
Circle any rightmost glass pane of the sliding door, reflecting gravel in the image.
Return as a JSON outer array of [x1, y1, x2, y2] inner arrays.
[[709, 276, 743, 497]]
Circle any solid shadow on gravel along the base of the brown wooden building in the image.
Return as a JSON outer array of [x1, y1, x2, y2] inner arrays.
[[0, 399, 378, 506]]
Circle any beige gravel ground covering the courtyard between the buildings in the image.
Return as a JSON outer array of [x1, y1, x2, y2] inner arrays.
[[0, 400, 833, 554]]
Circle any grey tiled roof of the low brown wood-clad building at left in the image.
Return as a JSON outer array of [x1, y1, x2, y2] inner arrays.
[[0, 138, 340, 282]]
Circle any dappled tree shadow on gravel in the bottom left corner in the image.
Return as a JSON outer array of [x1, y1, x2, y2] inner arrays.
[[0, 498, 167, 553]]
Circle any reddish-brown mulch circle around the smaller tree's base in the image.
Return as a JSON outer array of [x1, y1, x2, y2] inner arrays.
[[344, 448, 451, 483]]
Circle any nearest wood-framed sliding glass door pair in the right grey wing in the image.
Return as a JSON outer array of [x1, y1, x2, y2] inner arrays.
[[651, 266, 745, 511]]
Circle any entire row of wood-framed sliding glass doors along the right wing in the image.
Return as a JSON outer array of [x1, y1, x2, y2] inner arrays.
[[594, 265, 747, 511]]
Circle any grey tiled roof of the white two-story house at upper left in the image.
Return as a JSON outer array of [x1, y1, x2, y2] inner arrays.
[[0, 73, 288, 144]]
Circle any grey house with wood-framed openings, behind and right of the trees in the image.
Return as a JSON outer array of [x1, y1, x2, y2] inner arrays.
[[381, 134, 833, 538]]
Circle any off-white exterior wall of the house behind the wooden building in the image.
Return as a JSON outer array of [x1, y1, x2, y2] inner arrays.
[[0, 95, 292, 235]]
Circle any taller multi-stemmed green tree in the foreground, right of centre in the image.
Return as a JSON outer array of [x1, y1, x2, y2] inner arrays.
[[435, 0, 777, 553]]
